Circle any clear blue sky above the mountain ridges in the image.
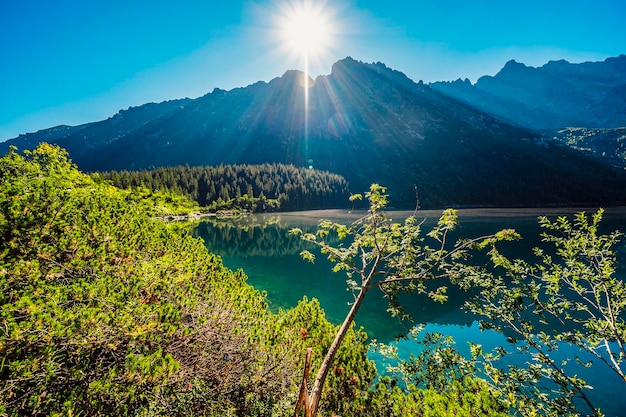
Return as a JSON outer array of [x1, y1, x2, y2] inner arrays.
[[0, 0, 626, 141]]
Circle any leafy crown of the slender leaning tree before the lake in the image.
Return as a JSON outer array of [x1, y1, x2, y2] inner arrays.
[[291, 184, 504, 317]]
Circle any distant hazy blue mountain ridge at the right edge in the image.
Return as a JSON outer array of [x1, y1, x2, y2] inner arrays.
[[430, 55, 626, 129]]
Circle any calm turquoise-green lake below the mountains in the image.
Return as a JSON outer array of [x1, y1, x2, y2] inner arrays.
[[196, 208, 626, 415]]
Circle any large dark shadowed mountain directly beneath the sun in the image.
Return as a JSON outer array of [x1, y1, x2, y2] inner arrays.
[[3, 58, 626, 208]]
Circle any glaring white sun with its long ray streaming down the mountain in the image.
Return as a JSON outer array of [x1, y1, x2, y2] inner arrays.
[[251, 0, 360, 169]]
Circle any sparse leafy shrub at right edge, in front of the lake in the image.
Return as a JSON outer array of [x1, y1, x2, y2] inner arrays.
[[454, 210, 626, 416]]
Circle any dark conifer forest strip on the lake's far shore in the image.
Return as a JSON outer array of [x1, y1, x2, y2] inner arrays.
[[98, 164, 348, 212]]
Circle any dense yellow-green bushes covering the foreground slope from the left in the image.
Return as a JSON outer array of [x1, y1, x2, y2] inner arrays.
[[0, 144, 508, 416]]
